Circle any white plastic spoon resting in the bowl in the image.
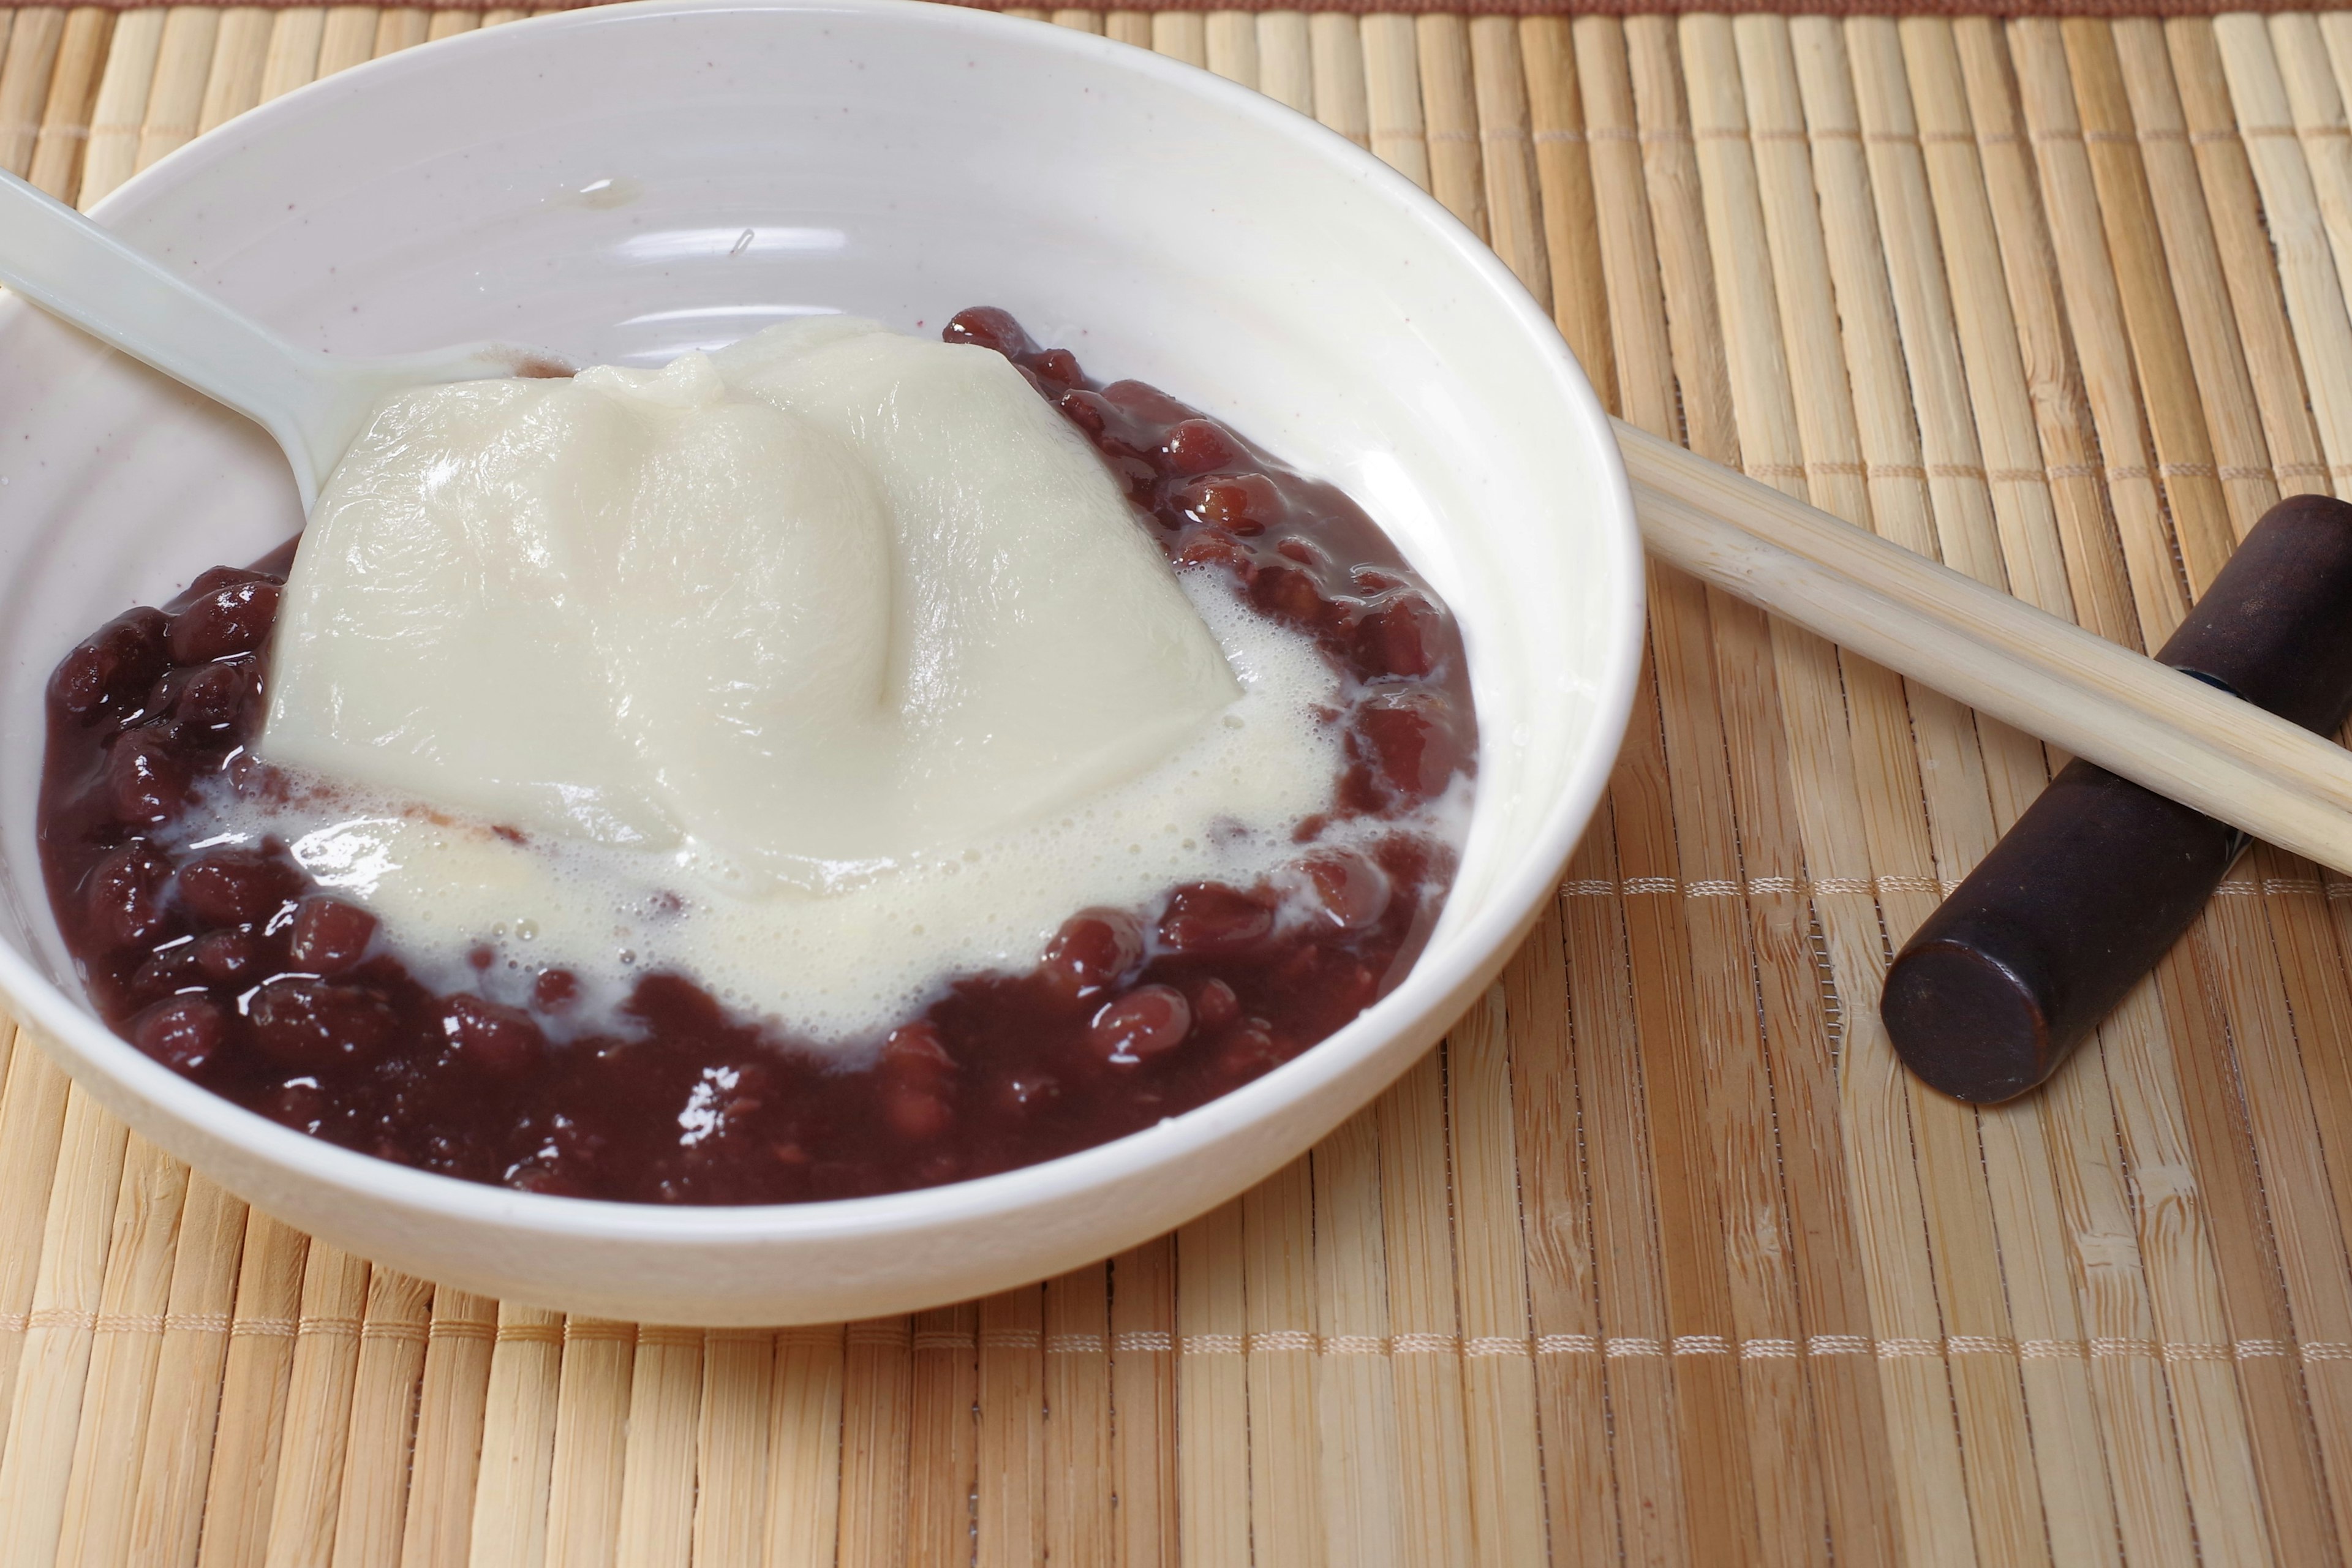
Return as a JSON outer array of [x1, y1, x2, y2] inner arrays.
[[0, 172, 562, 515]]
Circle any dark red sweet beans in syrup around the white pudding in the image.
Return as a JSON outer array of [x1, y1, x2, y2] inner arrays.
[[40, 311, 1475, 1204]]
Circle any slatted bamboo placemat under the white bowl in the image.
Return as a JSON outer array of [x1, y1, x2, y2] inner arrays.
[[13, 7, 2352, 1568]]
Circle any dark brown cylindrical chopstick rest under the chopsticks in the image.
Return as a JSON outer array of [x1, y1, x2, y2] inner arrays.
[[1879, 496, 2352, 1105]]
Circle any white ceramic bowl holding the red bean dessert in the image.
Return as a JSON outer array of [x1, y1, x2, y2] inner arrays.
[[0, 0, 1642, 1324]]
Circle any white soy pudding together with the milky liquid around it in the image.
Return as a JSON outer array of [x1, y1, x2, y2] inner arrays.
[[236, 317, 1373, 1044]]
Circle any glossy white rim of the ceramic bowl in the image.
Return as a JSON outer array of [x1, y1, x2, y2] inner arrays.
[[0, 0, 1646, 1246]]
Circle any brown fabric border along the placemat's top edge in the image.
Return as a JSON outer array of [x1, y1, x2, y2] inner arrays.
[[55, 0, 2345, 19]]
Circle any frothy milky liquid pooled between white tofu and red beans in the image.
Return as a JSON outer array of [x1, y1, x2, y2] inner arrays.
[[192, 571, 1382, 1044]]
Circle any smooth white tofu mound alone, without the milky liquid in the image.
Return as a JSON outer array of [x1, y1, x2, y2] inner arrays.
[[258, 317, 1240, 891]]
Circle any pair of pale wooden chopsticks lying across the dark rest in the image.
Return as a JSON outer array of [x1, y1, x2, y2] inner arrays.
[[1616, 421, 2352, 872]]
